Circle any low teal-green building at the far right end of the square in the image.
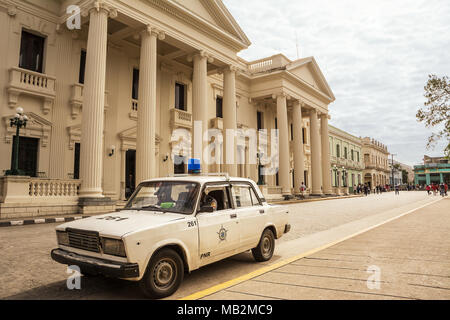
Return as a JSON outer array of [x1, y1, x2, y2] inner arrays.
[[414, 156, 450, 186]]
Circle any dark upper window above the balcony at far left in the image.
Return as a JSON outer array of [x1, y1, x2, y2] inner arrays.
[[19, 31, 45, 73]]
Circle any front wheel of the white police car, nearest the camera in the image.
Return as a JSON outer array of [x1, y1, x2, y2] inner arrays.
[[139, 248, 184, 299]]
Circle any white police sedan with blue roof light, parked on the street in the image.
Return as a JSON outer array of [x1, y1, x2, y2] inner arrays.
[[51, 171, 290, 298]]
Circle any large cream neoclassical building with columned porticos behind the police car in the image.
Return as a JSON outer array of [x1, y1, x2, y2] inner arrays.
[[0, 0, 335, 218]]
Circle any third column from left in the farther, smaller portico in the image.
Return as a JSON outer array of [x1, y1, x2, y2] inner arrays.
[[310, 108, 323, 195]]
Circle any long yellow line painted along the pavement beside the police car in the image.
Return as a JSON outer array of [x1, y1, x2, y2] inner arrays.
[[179, 199, 442, 300]]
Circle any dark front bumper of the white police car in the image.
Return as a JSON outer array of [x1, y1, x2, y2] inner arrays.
[[51, 249, 139, 279]]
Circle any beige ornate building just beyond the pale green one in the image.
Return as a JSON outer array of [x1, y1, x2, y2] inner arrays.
[[362, 137, 391, 189]]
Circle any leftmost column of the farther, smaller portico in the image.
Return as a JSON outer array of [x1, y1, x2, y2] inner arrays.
[[276, 94, 291, 195]]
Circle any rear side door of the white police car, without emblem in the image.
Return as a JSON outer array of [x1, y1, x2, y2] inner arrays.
[[231, 183, 266, 249]]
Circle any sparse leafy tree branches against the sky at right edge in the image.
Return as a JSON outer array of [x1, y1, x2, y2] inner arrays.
[[416, 74, 450, 157]]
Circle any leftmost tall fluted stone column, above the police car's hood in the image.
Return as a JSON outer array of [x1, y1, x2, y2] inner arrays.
[[79, 6, 109, 199]]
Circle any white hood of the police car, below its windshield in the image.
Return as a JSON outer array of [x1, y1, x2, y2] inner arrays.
[[57, 210, 186, 237]]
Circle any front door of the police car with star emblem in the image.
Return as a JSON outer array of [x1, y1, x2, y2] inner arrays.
[[197, 184, 239, 265]]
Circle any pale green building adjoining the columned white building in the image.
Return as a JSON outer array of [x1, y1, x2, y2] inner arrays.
[[329, 125, 364, 194]]
